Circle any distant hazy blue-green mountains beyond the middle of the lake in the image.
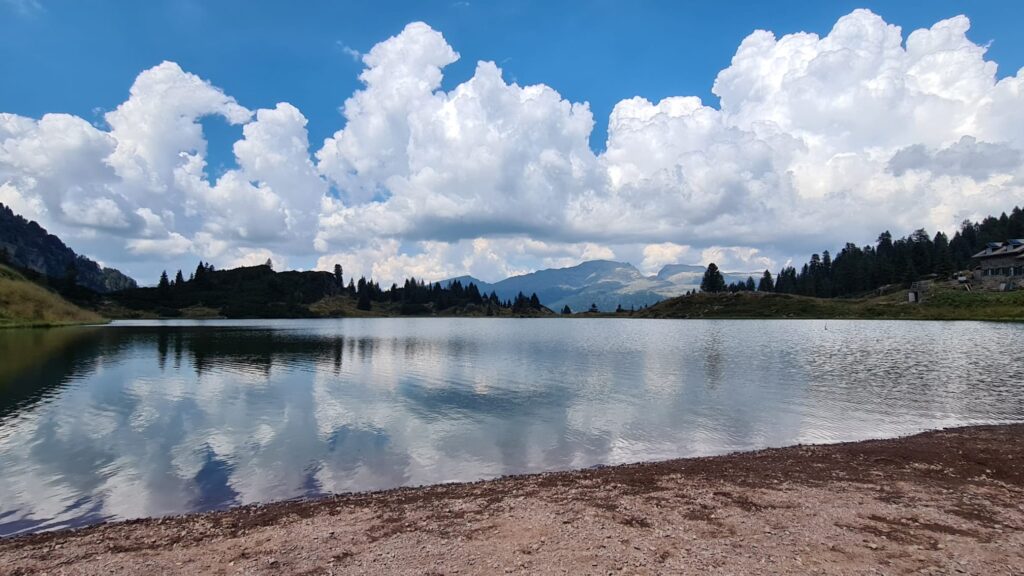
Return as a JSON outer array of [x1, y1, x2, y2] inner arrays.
[[441, 260, 760, 312]]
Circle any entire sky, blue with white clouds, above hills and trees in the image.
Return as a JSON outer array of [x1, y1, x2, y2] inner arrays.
[[0, 0, 1024, 284]]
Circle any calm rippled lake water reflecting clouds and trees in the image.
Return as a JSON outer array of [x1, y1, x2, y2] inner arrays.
[[0, 319, 1024, 535]]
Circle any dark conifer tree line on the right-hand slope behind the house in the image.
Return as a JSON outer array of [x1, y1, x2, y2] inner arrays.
[[700, 207, 1024, 298]]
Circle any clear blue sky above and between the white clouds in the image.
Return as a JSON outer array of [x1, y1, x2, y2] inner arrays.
[[0, 0, 1024, 158]]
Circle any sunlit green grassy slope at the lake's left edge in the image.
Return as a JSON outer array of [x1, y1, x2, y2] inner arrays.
[[0, 264, 103, 328]]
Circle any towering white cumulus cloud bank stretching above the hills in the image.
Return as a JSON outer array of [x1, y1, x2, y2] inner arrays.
[[0, 10, 1024, 282]]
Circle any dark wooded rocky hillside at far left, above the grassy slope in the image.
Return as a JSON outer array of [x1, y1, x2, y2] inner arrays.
[[0, 204, 137, 293]]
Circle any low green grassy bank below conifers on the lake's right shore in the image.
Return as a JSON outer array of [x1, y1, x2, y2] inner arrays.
[[636, 285, 1024, 321]]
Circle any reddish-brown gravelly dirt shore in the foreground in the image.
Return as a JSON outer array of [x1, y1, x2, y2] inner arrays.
[[0, 425, 1024, 575]]
